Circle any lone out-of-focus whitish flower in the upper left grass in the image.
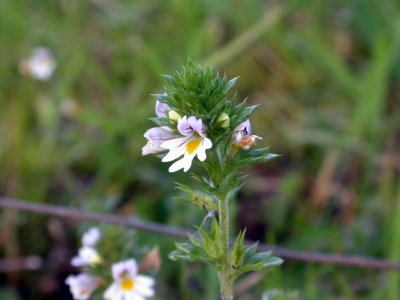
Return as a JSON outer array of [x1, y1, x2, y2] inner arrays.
[[19, 47, 56, 81]]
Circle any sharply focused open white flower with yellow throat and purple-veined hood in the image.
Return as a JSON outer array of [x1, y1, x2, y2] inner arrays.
[[160, 116, 212, 172]]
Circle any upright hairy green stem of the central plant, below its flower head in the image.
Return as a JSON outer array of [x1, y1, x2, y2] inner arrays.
[[218, 195, 233, 300]]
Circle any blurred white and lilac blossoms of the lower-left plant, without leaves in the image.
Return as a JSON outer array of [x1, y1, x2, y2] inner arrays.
[[65, 227, 155, 300]]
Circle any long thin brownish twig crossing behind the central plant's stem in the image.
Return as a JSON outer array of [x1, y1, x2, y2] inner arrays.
[[0, 198, 400, 271]]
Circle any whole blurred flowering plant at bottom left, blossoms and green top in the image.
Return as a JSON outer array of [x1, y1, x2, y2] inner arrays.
[[65, 227, 160, 300]]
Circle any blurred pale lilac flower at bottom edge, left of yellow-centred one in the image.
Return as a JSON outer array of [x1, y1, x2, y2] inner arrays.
[[65, 273, 99, 300]]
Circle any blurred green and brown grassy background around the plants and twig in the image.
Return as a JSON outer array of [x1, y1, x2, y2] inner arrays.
[[0, 0, 400, 299]]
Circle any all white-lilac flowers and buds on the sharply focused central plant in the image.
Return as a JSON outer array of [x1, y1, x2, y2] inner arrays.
[[142, 100, 262, 173]]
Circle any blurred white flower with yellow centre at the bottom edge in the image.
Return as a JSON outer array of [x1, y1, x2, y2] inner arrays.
[[104, 259, 155, 300]]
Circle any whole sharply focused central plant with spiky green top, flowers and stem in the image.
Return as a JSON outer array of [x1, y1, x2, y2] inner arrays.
[[142, 59, 283, 300]]
